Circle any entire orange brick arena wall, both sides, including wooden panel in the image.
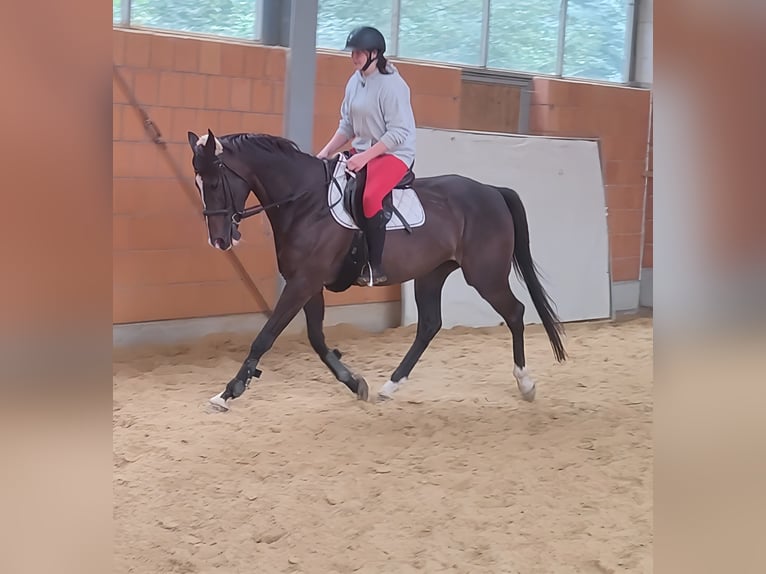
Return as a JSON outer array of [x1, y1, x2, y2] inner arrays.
[[113, 29, 651, 346]]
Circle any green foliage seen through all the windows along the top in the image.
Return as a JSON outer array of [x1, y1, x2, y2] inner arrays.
[[112, 0, 627, 82]]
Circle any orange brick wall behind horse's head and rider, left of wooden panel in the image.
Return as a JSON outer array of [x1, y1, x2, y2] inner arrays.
[[113, 29, 461, 323]]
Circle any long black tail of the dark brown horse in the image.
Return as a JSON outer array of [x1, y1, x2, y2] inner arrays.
[[495, 187, 567, 363]]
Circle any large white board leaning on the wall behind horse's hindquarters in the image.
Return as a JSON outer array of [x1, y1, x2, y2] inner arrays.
[[402, 128, 611, 328]]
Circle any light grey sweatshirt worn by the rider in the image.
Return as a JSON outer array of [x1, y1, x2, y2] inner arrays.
[[339, 62, 415, 167]]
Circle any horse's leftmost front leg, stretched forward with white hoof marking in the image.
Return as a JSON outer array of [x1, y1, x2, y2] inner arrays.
[[210, 279, 316, 410]]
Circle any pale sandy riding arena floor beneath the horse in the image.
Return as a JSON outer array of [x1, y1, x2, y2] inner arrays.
[[114, 318, 652, 574]]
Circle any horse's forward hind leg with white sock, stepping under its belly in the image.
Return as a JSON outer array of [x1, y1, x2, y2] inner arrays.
[[378, 261, 458, 399]]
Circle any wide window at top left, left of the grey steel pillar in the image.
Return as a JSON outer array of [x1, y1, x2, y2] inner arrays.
[[123, 0, 255, 40]]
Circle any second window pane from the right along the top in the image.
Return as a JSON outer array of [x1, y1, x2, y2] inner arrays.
[[487, 0, 561, 74]]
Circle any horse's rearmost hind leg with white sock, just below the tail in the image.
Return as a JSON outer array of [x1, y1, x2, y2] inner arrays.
[[463, 272, 535, 402]]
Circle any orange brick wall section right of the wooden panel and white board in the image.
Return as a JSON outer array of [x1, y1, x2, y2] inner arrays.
[[530, 78, 651, 281]]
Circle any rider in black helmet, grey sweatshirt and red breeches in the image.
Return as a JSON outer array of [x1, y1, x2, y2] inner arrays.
[[317, 26, 415, 286]]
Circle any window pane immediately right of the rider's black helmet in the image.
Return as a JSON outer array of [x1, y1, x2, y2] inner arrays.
[[397, 0, 484, 66]]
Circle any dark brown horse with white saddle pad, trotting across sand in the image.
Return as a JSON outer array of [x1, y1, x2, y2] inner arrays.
[[188, 129, 567, 410]]
